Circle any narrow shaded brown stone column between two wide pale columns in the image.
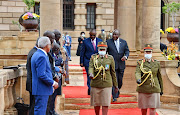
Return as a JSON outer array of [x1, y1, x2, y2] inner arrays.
[[136, 0, 143, 53]]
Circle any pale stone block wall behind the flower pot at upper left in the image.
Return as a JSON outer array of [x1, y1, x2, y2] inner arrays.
[[0, 0, 33, 36]]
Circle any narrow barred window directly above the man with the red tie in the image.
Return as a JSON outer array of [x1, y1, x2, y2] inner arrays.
[[86, 4, 96, 29]]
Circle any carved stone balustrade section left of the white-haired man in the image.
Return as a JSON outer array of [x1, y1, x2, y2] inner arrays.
[[0, 64, 28, 115]]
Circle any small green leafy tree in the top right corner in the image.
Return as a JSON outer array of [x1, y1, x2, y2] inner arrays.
[[162, 2, 180, 28]]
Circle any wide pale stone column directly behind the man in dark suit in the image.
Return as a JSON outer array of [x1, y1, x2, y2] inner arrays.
[[115, 0, 137, 56]]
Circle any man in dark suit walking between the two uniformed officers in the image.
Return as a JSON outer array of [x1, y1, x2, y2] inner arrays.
[[107, 29, 129, 101]]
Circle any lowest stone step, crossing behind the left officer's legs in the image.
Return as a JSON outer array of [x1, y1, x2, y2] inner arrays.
[[65, 103, 138, 110]]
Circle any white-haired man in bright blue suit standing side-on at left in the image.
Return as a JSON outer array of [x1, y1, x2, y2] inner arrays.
[[31, 37, 58, 115]]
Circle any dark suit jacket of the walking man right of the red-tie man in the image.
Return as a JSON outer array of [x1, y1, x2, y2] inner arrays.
[[107, 38, 129, 70]]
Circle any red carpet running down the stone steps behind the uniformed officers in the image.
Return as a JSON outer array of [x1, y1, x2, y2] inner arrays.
[[66, 65, 158, 115]]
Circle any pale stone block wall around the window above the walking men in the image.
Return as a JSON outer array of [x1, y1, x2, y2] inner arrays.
[[67, 0, 114, 54]]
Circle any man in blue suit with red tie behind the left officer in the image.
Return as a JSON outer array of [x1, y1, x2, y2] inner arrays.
[[80, 29, 102, 95]]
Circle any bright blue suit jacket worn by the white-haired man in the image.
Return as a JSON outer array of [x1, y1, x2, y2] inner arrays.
[[31, 49, 54, 95]]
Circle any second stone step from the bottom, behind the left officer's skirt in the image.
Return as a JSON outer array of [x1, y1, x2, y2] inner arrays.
[[65, 97, 137, 104]]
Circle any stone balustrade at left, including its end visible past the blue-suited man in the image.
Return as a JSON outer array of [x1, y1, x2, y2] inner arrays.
[[0, 64, 65, 115]]
